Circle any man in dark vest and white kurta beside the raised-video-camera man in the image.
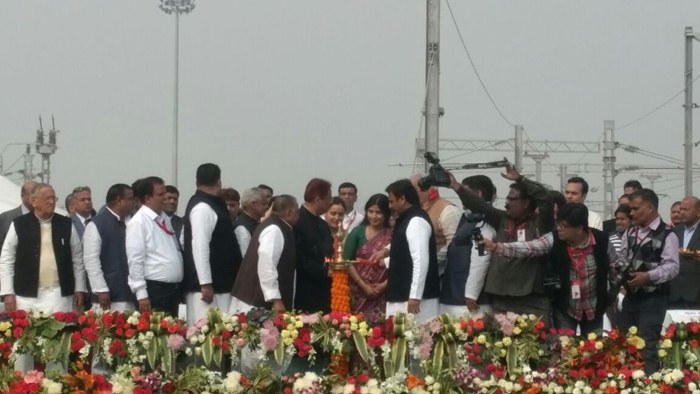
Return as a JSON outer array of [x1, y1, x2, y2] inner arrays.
[[440, 175, 496, 316]]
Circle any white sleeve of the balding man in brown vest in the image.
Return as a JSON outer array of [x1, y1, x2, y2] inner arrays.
[[258, 225, 284, 302]]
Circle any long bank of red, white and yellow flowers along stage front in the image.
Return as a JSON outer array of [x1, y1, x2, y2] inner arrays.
[[0, 309, 700, 394]]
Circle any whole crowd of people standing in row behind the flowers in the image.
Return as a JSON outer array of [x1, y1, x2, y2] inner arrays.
[[0, 163, 700, 372]]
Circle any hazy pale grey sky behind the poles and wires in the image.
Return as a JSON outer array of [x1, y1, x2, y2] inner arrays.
[[0, 0, 700, 218]]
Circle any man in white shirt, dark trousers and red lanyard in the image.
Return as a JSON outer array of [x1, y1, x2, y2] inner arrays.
[[126, 177, 184, 316]]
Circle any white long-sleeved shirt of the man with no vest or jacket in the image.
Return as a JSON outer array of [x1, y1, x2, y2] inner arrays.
[[126, 205, 183, 300]]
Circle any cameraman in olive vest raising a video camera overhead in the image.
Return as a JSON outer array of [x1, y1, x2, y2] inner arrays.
[[450, 164, 554, 325]]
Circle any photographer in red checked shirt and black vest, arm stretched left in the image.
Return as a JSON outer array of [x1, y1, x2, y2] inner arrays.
[[482, 203, 619, 335]]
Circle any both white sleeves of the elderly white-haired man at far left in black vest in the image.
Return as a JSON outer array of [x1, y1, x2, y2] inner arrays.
[[0, 215, 87, 295]]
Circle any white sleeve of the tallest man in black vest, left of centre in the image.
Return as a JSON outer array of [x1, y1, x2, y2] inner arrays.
[[190, 202, 218, 285]]
